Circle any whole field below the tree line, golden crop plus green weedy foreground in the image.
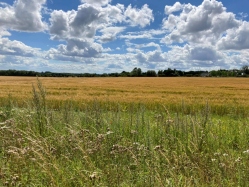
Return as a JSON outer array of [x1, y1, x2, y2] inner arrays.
[[0, 77, 249, 186]]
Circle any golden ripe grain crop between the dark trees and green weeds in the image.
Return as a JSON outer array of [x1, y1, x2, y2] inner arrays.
[[0, 77, 249, 111]]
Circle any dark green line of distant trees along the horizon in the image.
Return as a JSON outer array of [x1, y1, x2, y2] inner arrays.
[[0, 65, 249, 77]]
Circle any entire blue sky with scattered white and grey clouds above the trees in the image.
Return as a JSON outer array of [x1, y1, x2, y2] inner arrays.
[[0, 0, 249, 73]]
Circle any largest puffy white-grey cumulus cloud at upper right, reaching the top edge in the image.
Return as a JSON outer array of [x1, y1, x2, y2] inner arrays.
[[162, 0, 240, 44]]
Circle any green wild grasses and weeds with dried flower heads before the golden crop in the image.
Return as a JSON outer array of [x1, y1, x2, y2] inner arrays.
[[0, 77, 249, 186]]
